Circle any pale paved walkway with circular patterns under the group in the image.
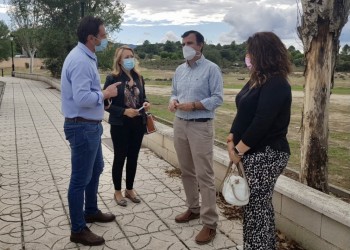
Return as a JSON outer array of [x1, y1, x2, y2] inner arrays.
[[0, 77, 242, 250]]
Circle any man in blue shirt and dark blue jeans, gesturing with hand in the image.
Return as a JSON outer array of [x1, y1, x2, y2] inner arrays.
[[61, 17, 118, 246]]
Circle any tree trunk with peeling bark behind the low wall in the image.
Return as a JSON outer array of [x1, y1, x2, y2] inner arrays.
[[298, 0, 350, 193]]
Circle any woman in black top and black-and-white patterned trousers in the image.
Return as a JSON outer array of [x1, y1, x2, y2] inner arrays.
[[227, 32, 292, 250]]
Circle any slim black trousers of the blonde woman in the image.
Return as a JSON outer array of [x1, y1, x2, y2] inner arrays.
[[111, 117, 145, 190]]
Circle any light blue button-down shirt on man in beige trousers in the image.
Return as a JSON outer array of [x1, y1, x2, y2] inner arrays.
[[170, 55, 223, 119]]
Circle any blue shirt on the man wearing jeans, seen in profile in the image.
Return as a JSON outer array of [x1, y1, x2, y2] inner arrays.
[[61, 42, 104, 120]]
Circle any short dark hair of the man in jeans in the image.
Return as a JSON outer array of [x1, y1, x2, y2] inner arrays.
[[77, 16, 103, 44]]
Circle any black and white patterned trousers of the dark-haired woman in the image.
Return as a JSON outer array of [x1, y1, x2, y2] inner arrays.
[[242, 146, 289, 250]]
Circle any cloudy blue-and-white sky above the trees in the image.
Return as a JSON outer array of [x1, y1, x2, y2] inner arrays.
[[0, 0, 350, 50]]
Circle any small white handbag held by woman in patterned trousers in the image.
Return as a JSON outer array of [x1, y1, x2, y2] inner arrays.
[[222, 162, 250, 206]]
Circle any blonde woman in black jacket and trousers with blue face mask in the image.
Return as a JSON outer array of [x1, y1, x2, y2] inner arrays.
[[104, 46, 150, 206]]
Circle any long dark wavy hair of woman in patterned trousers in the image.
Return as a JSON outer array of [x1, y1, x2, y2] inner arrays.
[[247, 32, 292, 87]]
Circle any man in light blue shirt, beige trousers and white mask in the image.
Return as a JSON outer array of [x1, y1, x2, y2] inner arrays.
[[169, 30, 223, 244]]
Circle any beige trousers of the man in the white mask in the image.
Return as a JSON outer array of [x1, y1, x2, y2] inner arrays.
[[174, 118, 218, 229]]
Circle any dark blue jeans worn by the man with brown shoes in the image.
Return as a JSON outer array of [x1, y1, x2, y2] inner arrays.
[[64, 122, 104, 233]]
